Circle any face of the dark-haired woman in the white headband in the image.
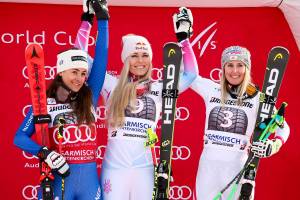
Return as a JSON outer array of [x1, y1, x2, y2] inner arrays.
[[59, 68, 87, 92]]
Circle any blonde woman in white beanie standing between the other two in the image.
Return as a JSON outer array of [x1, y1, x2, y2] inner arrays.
[[101, 7, 197, 200]]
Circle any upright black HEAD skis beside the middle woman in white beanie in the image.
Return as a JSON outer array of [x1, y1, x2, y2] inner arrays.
[[153, 42, 182, 200]]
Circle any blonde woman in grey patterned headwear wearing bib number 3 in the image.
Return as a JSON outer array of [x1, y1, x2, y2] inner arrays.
[[191, 46, 290, 200]]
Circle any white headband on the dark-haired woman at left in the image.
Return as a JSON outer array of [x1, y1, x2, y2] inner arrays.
[[56, 49, 88, 73]]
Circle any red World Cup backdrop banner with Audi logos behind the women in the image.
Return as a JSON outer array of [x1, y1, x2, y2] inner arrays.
[[0, 3, 300, 200]]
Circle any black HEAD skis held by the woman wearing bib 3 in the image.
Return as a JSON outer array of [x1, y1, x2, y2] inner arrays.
[[239, 46, 289, 200]]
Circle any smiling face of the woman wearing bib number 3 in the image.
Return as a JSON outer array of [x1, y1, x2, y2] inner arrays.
[[224, 60, 246, 85]]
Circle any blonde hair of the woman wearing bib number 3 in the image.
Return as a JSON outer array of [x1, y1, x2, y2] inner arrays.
[[220, 65, 252, 105]]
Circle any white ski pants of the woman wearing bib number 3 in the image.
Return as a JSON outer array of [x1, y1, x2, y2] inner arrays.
[[195, 149, 254, 200]]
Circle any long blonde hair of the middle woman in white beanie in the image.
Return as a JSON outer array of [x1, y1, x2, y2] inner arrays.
[[107, 57, 152, 127]]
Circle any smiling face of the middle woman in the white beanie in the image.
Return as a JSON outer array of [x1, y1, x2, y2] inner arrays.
[[129, 52, 151, 77]]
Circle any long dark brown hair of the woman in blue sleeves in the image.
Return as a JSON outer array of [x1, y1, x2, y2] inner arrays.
[[47, 75, 95, 125]]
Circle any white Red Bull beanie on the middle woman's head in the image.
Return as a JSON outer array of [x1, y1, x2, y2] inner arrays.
[[121, 35, 152, 63]]
